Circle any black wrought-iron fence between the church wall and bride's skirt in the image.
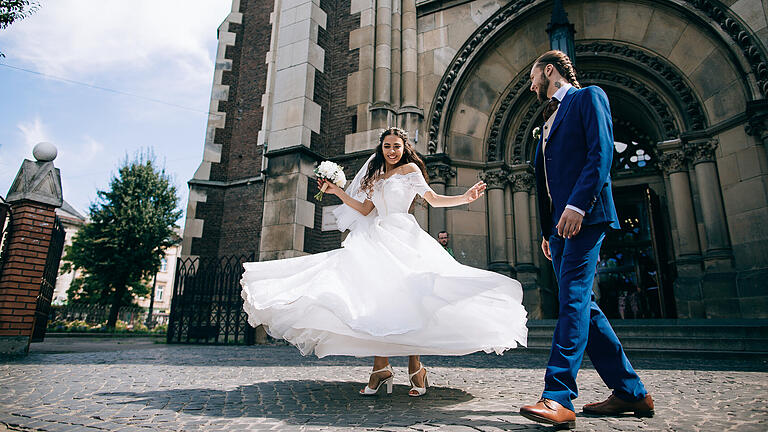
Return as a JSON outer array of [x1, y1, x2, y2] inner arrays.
[[167, 254, 255, 345]]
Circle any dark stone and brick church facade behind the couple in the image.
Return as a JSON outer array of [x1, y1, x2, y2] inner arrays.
[[182, 0, 768, 319]]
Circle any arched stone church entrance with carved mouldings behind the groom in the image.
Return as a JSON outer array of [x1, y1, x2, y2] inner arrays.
[[426, 1, 768, 318]]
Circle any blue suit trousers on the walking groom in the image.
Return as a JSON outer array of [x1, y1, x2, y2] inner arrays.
[[542, 224, 646, 410]]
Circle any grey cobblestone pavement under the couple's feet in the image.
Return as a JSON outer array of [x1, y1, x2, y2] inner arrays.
[[0, 341, 768, 432]]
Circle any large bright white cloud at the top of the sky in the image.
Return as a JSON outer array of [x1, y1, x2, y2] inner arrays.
[[0, 0, 232, 104]]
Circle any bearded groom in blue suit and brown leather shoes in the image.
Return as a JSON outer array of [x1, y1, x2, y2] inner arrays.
[[520, 51, 653, 428]]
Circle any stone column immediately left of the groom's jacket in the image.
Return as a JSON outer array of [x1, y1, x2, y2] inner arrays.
[[510, 164, 543, 319]]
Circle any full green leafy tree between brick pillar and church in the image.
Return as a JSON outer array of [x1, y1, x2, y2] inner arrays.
[[63, 154, 181, 328]]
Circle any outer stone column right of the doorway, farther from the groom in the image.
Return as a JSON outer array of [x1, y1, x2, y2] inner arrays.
[[686, 139, 732, 269]]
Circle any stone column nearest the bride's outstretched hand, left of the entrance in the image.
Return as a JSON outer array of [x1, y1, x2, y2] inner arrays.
[[480, 166, 510, 274]]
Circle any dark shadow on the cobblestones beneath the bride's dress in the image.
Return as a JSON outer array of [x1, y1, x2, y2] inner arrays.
[[94, 380, 551, 431]]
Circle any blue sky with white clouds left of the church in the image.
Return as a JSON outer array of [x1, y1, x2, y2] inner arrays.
[[0, 0, 232, 223]]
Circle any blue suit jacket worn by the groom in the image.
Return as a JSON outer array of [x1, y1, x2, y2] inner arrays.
[[535, 86, 619, 239]]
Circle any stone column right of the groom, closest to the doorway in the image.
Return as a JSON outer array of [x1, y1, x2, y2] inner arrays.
[[657, 139, 704, 318]]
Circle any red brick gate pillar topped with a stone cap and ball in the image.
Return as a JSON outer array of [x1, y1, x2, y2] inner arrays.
[[0, 143, 62, 354]]
